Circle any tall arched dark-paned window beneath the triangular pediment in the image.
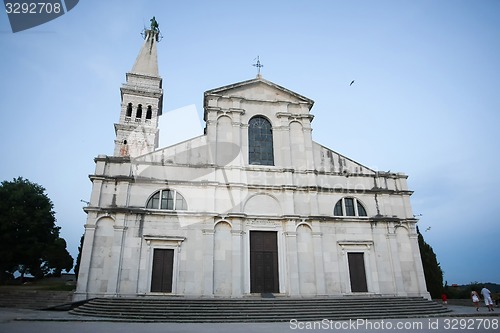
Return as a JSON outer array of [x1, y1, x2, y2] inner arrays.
[[248, 116, 274, 165]]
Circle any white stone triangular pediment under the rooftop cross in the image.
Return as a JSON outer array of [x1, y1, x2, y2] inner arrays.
[[205, 77, 314, 109]]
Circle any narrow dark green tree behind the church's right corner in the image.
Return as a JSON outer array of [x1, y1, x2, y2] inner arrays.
[[417, 227, 443, 298]]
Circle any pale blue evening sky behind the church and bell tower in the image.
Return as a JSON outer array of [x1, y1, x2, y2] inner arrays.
[[0, 0, 500, 284]]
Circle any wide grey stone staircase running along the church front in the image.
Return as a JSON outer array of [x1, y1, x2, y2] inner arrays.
[[70, 297, 450, 323]]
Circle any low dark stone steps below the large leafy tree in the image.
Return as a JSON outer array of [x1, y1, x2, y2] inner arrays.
[[0, 288, 73, 310]]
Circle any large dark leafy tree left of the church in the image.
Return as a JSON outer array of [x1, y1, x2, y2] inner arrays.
[[0, 177, 73, 278]]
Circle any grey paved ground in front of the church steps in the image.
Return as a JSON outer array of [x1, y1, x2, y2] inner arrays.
[[0, 306, 500, 333]]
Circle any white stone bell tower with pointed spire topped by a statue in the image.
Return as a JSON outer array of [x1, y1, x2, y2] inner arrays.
[[114, 17, 163, 157]]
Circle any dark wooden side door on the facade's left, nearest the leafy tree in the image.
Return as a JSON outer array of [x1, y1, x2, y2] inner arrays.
[[151, 249, 174, 293]]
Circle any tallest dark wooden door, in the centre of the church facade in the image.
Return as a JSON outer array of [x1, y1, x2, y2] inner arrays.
[[250, 231, 279, 293]]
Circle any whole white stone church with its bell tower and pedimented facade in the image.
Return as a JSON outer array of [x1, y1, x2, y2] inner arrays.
[[75, 29, 429, 300]]
